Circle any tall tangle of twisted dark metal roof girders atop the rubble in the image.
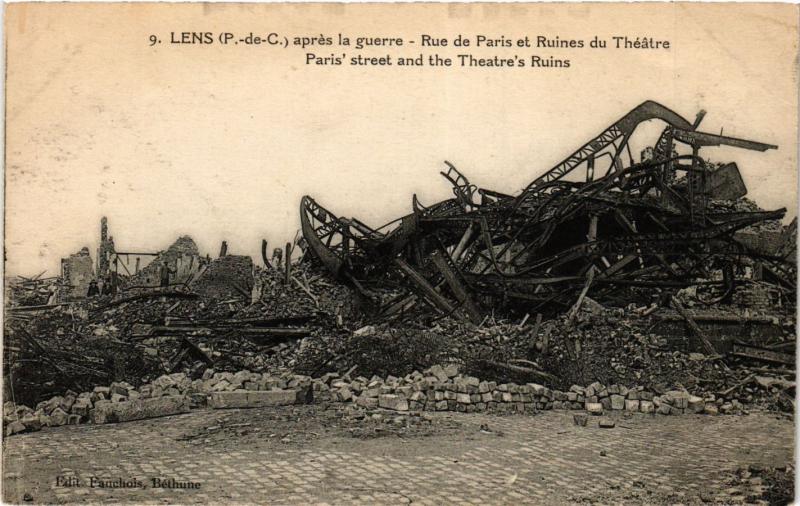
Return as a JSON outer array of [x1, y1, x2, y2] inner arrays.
[[300, 101, 796, 321]]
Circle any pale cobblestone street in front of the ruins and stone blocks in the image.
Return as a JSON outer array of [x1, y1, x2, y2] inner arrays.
[[3, 407, 794, 504]]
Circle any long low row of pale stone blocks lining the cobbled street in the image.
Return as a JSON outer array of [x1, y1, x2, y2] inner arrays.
[[3, 364, 756, 435]]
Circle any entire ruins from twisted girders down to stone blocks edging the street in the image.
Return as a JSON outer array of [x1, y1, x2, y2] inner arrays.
[[4, 101, 797, 502]]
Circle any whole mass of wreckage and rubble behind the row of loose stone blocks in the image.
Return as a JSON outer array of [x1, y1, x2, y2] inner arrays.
[[4, 101, 796, 416]]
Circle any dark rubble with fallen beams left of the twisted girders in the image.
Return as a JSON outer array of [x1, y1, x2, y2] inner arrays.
[[4, 257, 356, 403]]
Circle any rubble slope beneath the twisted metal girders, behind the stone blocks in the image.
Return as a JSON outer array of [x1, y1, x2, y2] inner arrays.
[[295, 303, 794, 412]]
